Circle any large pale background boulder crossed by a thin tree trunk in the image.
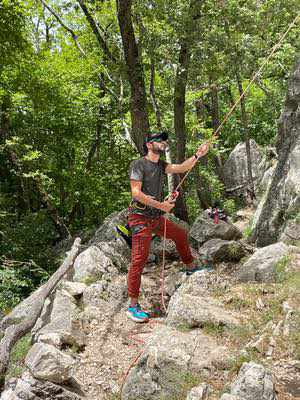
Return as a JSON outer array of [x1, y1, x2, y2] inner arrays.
[[223, 139, 265, 189]]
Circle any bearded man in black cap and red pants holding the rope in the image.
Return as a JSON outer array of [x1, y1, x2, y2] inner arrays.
[[127, 132, 209, 322]]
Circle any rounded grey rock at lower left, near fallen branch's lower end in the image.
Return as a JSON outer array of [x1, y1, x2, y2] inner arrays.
[[25, 343, 75, 383]]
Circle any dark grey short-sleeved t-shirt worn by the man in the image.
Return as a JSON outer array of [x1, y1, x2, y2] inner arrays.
[[129, 157, 168, 218]]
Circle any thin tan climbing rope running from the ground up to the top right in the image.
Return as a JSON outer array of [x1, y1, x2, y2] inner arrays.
[[161, 13, 300, 312]]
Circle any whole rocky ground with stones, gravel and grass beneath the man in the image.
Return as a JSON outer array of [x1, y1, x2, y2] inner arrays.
[[1, 209, 300, 400]]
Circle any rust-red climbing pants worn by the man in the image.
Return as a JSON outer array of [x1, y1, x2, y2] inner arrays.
[[127, 214, 193, 298]]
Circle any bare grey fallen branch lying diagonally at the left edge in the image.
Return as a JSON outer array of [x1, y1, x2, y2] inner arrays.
[[0, 238, 81, 375]]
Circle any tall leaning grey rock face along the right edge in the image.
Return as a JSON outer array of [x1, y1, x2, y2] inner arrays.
[[252, 59, 300, 247]]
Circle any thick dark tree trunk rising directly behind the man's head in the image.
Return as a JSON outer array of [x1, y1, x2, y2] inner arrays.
[[117, 0, 149, 155]]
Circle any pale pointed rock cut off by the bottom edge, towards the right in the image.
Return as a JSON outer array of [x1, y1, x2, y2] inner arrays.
[[231, 362, 276, 400]]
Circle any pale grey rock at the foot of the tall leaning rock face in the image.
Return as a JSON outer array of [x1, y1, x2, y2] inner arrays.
[[237, 242, 289, 282]]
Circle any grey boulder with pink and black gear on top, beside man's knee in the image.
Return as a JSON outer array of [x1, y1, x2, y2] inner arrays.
[[189, 213, 242, 246]]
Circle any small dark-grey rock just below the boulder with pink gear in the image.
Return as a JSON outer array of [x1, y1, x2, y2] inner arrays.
[[199, 239, 247, 263]]
